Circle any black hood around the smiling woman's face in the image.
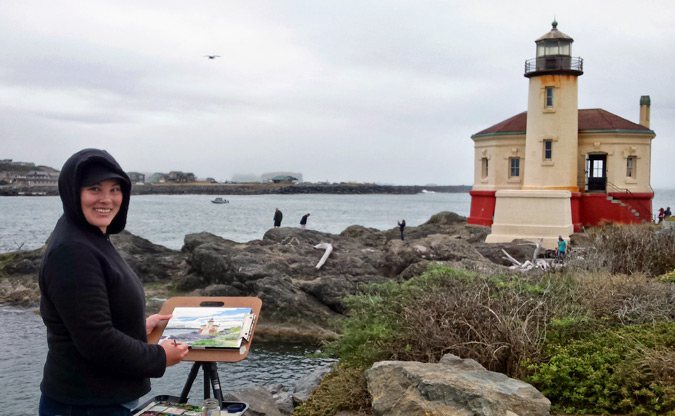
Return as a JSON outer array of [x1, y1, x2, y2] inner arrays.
[[59, 149, 131, 234]]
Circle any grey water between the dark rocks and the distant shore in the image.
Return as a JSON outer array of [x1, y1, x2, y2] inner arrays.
[[0, 193, 471, 253]]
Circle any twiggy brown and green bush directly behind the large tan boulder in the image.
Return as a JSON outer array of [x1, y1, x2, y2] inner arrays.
[[326, 266, 572, 376]]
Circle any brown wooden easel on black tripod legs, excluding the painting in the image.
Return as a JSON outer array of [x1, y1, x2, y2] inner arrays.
[[148, 296, 262, 403]]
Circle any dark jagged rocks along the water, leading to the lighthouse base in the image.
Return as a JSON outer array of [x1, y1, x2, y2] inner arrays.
[[0, 212, 532, 341]]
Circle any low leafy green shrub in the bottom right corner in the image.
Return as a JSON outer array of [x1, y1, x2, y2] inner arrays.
[[526, 322, 675, 416]]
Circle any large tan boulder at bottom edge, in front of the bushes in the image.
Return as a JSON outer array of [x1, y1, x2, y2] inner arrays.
[[366, 354, 551, 416]]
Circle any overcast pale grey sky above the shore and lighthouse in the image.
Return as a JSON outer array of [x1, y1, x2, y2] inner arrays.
[[0, 0, 675, 188]]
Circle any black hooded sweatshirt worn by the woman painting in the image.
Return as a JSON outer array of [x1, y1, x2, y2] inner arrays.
[[39, 149, 166, 406]]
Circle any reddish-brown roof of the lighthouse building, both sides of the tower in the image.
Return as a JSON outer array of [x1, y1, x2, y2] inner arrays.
[[471, 108, 651, 137]]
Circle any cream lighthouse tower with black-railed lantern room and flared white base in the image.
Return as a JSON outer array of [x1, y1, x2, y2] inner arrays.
[[486, 21, 583, 248]]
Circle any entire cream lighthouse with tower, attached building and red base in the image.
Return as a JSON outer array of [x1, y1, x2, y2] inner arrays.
[[468, 22, 655, 247]]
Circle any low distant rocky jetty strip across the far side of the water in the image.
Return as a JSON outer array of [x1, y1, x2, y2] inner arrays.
[[0, 183, 471, 196]]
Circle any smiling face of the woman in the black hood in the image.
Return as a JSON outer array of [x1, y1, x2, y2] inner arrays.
[[80, 180, 123, 234]]
